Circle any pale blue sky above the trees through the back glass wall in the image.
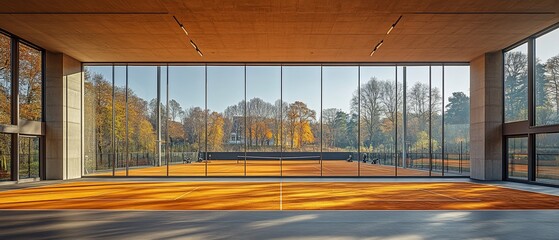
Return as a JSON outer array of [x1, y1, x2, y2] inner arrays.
[[88, 66, 470, 117]]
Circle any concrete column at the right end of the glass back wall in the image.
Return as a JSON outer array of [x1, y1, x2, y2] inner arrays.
[[470, 51, 504, 180]]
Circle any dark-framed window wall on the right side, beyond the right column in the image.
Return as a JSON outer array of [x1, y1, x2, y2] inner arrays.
[[503, 25, 559, 185]]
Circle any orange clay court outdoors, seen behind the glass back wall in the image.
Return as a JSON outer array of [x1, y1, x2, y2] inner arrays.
[[91, 160, 464, 177]]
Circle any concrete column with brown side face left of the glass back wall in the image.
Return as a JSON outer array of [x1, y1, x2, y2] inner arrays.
[[45, 51, 83, 180]]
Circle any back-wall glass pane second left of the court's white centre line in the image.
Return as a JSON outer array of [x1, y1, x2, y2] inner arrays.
[[207, 66, 245, 176]]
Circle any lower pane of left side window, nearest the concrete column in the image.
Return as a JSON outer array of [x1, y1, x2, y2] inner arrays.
[[19, 137, 40, 179]]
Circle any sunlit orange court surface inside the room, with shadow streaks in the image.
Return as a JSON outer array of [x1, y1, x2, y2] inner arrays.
[[0, 182, 559, 210]]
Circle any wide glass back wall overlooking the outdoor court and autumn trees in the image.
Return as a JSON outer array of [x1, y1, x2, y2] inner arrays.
[[84, 64, 469, 176]]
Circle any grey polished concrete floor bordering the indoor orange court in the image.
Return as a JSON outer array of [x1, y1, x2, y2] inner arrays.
[[0, 179, 559, 239]]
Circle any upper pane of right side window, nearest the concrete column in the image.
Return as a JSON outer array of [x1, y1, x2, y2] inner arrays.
[[504, 43, 528, 122]]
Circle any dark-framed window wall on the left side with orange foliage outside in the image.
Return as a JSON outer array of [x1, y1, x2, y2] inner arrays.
[[0, 30, 44, 181]]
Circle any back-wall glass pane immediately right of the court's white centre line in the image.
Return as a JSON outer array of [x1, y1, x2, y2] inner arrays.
[[282, 66, 321, 176]]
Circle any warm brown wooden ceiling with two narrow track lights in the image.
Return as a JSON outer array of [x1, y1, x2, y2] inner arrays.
[[0, 0, 559, 62]]
